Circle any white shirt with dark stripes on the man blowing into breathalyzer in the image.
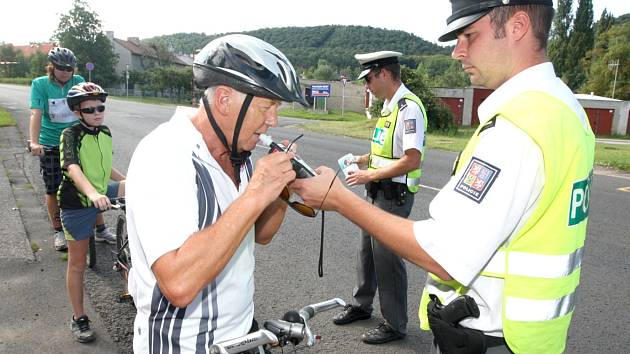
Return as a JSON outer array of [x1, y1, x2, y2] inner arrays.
[[126, 107, 254, 353]]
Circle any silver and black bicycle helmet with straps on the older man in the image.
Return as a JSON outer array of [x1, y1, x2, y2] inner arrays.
[[193, 34, 308, 184]]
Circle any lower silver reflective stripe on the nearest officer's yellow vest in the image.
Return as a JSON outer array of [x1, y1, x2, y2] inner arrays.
[[505, 292, 575, 322]]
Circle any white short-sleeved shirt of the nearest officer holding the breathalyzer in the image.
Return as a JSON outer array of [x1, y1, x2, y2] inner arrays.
[[413, 63, 587, 336]]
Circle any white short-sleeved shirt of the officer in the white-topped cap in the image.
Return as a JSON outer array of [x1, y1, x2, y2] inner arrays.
[[381, 84, 426, 183]]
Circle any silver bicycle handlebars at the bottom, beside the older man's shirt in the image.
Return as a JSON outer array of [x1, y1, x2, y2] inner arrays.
[[210, 298, 346, 354]]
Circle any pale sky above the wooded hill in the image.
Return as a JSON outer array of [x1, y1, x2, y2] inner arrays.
[[0, 0, 630, 45]]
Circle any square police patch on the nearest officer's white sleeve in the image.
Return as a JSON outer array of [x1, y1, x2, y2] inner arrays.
[[455, 157, 501, 204]]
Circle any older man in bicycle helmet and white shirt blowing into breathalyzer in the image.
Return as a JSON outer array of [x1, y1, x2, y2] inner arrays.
[[126, 34, 306, 353]]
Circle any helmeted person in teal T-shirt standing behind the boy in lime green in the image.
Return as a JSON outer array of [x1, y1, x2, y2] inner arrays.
[[29, 47, 115, 251]]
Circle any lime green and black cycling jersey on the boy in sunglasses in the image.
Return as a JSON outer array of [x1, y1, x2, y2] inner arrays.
[[57, 123, 112, 209]]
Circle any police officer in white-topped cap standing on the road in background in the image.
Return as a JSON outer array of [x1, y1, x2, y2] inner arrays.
[[333, 51, 427, 344]]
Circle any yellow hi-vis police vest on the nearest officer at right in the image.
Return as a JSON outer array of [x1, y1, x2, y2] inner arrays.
[[419, 92, 595, 353]]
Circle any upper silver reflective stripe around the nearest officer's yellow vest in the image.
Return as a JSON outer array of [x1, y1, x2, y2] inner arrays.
[[483, 247, 584, 278]]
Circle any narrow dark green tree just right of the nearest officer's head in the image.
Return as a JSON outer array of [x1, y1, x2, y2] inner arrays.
[[547, 0, 573, 76]]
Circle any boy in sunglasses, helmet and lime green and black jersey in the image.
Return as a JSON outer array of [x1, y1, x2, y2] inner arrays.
[[58, 82, 125, 343]]
